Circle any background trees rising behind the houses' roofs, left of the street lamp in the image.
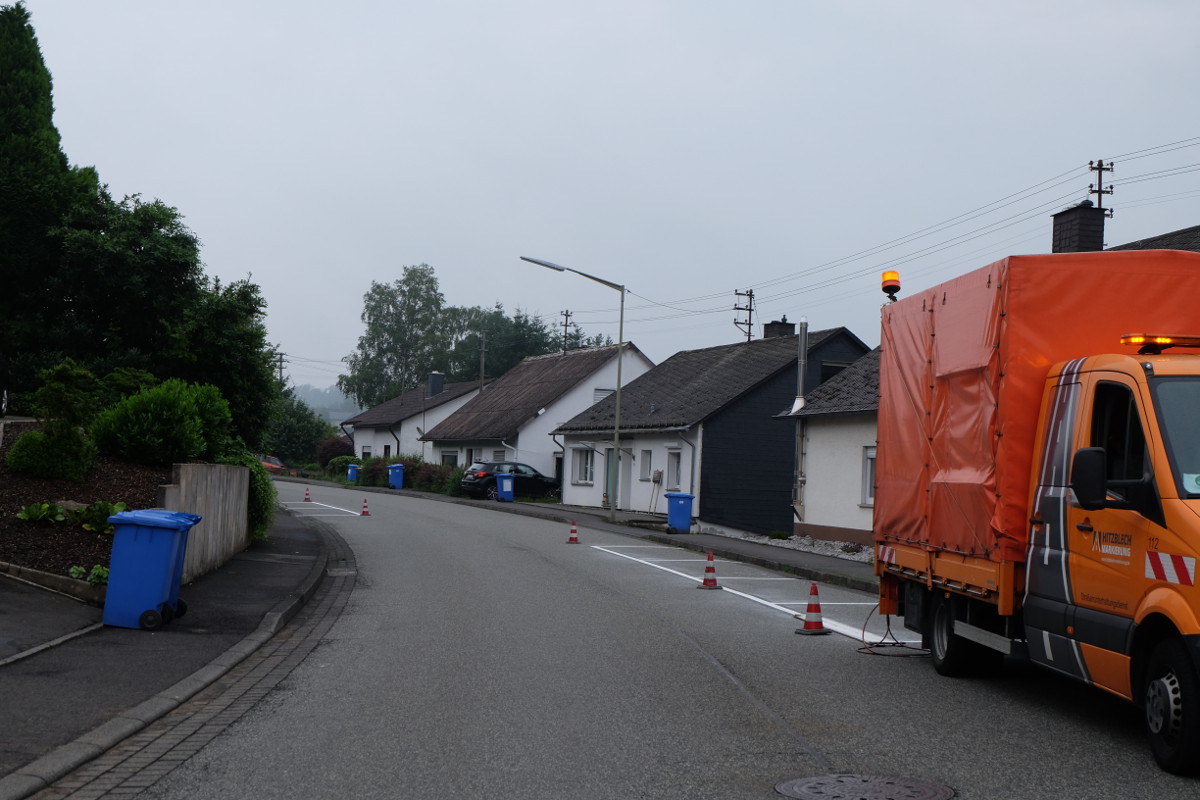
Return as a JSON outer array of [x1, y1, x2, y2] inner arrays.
[[337, 264, 612, 408]]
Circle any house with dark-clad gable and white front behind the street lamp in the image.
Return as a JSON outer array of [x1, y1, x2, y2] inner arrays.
[[554, 319, 868, 534]]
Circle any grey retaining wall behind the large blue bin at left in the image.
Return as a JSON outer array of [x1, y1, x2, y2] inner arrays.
[[158, 464, 250, 583]]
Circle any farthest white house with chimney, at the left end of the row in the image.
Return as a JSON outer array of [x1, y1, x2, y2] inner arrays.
[[341, 372, 480, 463]]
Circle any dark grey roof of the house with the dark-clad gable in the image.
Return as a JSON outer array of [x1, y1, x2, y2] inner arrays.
[[554, 327, 845, 433]]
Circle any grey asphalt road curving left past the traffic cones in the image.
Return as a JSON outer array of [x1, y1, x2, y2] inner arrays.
[[136, 483, 1200, 800]]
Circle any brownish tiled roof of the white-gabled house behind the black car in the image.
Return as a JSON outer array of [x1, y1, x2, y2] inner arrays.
[[422, 342, 638, 441]]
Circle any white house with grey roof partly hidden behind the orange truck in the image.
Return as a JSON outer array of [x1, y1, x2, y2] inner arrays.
[[788, 348, 880, 545]]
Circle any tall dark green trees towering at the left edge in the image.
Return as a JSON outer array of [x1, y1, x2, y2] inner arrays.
[[0, 4, 332, 461]]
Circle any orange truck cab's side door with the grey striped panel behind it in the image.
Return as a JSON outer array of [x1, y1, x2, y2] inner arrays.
[[1025, 361, 1162, 697]]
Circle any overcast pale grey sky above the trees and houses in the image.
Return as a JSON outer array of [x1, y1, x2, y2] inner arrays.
[[18, 0, 1200, 386]]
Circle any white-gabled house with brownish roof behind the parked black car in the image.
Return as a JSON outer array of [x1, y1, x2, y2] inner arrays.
[[422, 342, 654, 477]]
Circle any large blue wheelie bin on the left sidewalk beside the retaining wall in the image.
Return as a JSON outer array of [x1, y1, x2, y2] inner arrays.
[[103, 509, 200, 631]]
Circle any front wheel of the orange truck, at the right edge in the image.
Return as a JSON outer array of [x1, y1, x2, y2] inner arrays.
[[1142, 639, 1200, 775]]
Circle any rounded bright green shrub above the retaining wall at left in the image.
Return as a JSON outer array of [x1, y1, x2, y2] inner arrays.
[[92, 378, 230, 464]]
